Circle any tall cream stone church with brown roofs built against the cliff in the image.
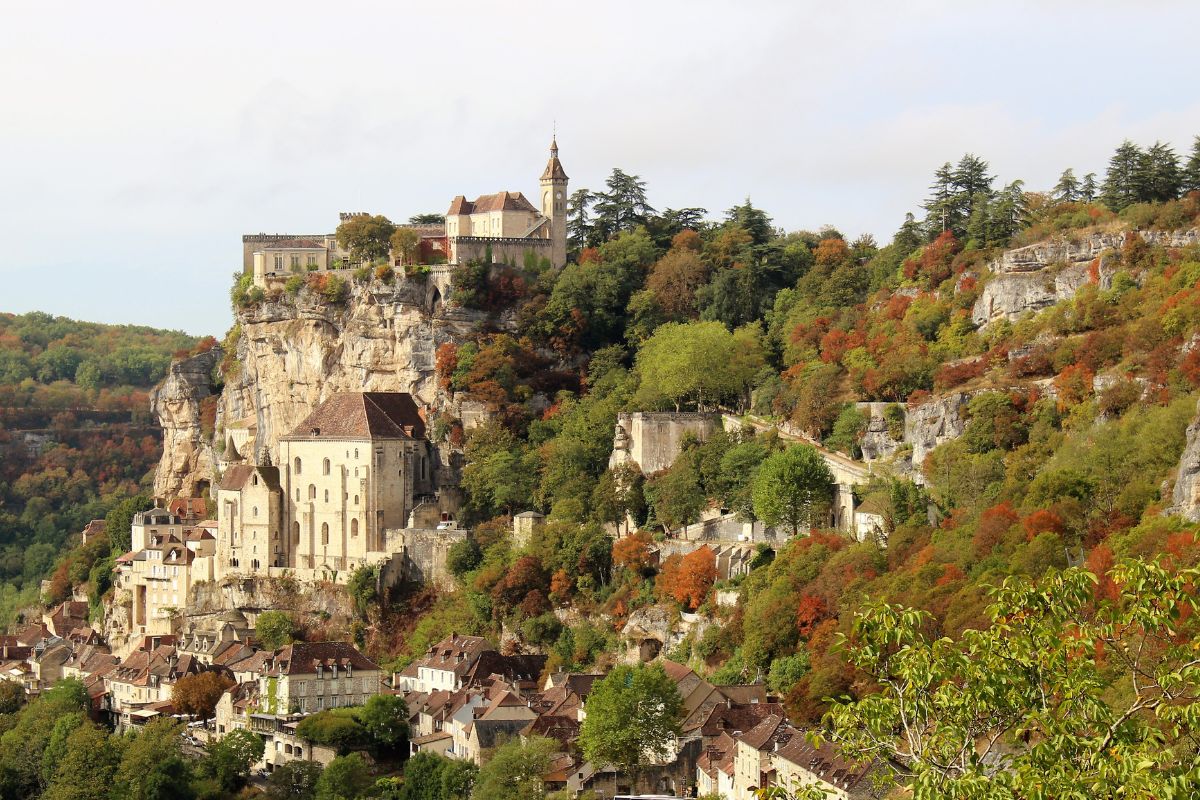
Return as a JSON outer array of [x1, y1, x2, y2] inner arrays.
[[217, 392, 450, 579]]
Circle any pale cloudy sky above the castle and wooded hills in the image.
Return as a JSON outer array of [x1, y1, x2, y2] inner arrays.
[[0, 0, 1200, 336]]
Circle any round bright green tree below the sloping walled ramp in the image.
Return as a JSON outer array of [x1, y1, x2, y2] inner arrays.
[[751, 445, 834, 536]]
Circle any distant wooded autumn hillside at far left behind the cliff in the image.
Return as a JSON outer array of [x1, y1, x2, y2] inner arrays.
[[0, 312, 200, 622]]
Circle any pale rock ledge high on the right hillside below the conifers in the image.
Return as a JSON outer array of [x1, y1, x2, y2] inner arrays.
[[971, 229, 1200, 327]]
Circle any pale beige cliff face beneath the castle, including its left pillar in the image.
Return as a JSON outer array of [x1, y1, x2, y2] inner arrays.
[[154, 276, 481, 497]]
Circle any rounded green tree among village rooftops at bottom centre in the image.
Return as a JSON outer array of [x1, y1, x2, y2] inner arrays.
[[580, 663, 683, 772]]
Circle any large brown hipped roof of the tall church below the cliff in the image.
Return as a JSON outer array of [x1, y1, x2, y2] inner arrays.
[[283, 392, 425, 440]]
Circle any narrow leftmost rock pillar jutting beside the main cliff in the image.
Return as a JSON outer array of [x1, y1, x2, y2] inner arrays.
[[150, 348, 223, 498]]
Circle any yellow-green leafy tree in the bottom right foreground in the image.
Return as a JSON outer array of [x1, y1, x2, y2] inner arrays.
[[827, 560, 1200, 799]]
